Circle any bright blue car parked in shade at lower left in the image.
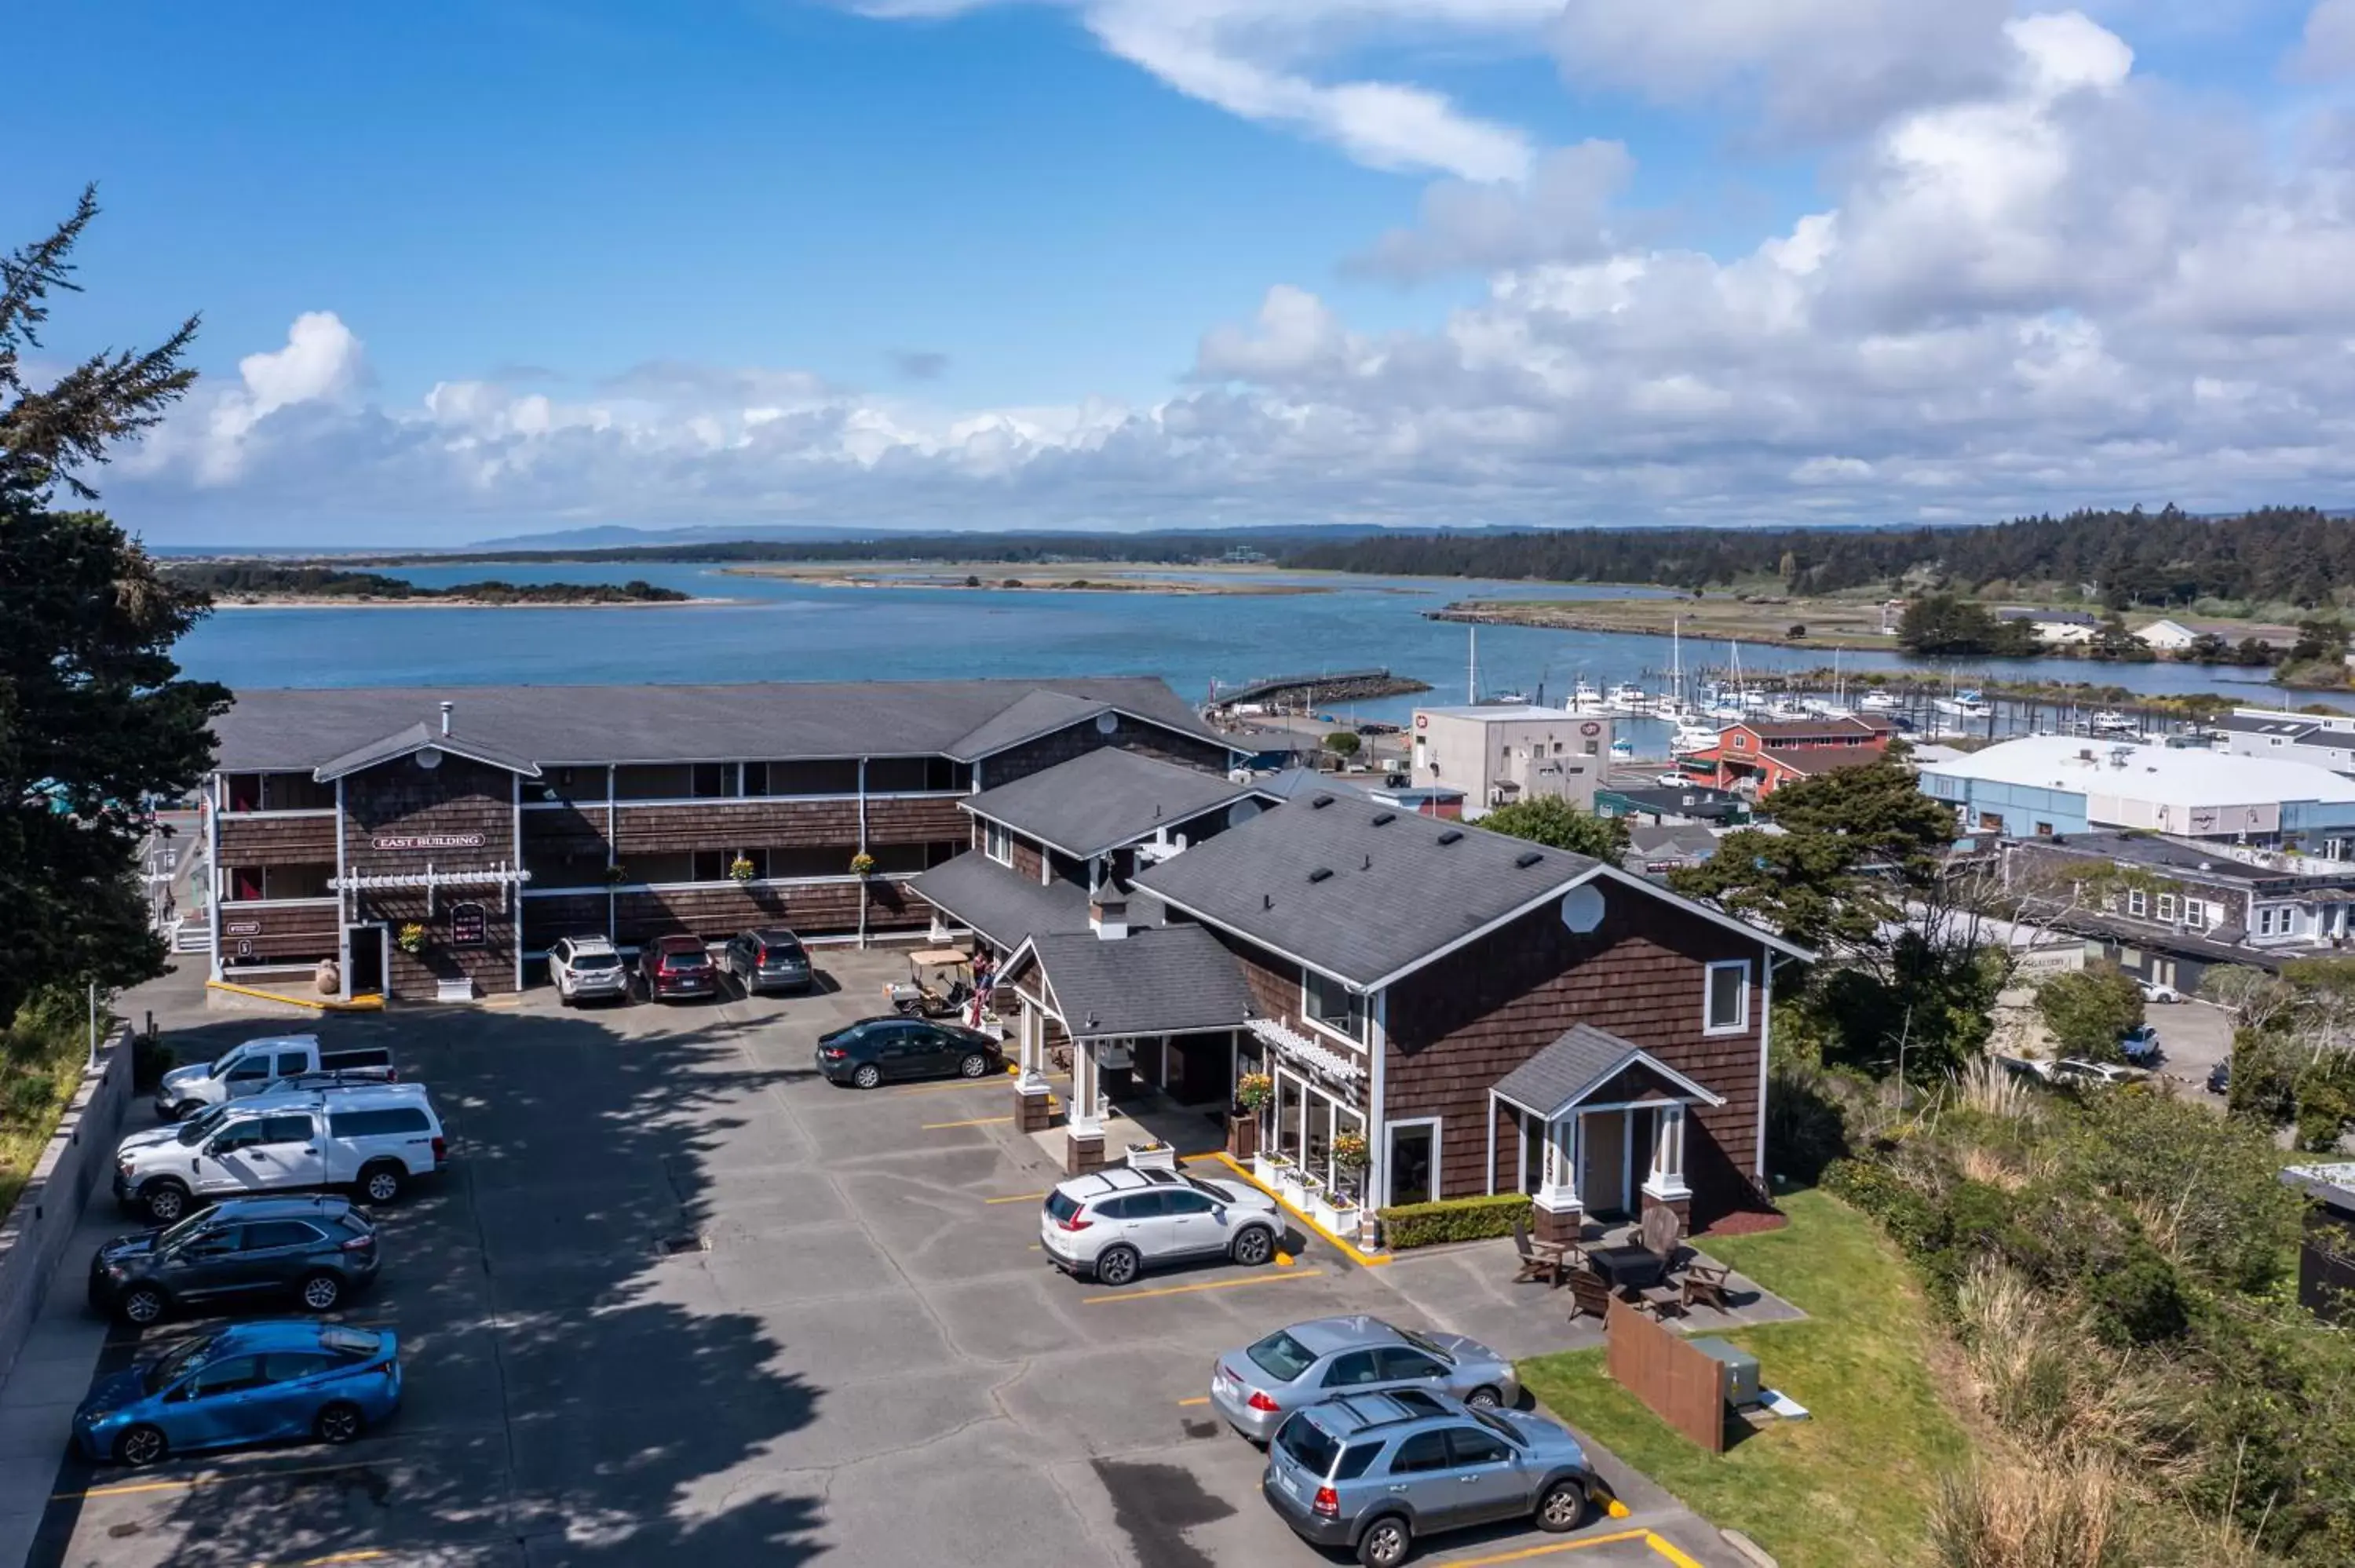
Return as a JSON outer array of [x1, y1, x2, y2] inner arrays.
[[73, 1323, 400, 1467]]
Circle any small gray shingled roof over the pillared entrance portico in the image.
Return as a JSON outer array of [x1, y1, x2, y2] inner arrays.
[[1031, 925, 1253, 1041]]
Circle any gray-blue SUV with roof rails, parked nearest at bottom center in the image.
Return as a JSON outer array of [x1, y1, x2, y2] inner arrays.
[[1260, 1389, 1608, 1568]]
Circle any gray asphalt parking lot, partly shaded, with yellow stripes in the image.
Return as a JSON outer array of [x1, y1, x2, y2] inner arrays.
[[0, 951, 1738, 1568]]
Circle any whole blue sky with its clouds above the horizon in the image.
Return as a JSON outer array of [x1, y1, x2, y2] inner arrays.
[[0, 0, 2355, 542]]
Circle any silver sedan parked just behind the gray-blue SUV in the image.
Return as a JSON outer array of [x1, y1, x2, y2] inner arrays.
[[1210, 1316, 1521, 1443]]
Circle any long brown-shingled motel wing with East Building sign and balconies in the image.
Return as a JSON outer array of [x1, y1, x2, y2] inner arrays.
[[203, 678, 1232, 1001]]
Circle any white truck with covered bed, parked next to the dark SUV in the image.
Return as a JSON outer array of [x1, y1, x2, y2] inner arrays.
[[115, 1083, 447, 1224]]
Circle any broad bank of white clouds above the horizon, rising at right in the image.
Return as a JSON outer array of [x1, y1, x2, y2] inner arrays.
[[111, 0, 2355, 539]]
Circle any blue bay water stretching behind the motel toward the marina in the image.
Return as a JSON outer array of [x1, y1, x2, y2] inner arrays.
[[179, 565, 2282, 720]]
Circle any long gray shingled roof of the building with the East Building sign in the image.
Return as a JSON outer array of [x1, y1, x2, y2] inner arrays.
[[212, 673, 1218, 770]]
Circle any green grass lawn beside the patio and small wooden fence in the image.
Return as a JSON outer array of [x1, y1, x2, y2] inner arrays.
[[1521, 1191, 1971, 1568]]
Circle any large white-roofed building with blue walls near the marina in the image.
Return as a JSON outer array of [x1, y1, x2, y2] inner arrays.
[[1919, 735, 2355, 859]]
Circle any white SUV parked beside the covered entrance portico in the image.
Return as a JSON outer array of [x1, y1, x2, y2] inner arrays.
[[1039, 1165, 1281, 1285]]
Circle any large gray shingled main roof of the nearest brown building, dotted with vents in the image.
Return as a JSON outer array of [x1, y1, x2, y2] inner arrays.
[[1135, 791, 1599, 986]]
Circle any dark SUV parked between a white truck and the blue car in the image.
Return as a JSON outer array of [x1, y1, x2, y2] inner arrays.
[[89, 1198, 379, 1323]]
